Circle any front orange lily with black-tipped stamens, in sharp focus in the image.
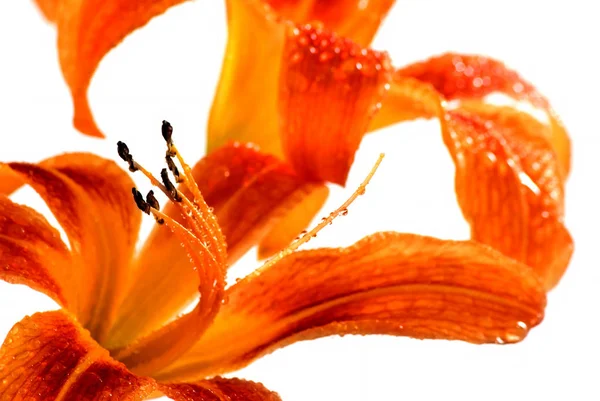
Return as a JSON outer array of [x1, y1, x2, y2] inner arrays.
[[0, 123, 546, 401]]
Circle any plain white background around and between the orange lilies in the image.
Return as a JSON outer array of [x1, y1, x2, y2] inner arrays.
[[0, 0, 600, 401]]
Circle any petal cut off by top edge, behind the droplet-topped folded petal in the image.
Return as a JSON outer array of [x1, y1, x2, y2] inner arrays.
[[266, 0, 395, 46]]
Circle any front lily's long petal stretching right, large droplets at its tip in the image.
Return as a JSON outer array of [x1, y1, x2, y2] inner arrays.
[[157, 233, 546, 380]]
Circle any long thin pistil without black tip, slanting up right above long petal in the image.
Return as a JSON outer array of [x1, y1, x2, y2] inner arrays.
[[253, 153, 385, 274]]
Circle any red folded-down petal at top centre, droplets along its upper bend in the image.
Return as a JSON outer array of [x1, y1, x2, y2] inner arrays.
[[280, 25, 391, 185]]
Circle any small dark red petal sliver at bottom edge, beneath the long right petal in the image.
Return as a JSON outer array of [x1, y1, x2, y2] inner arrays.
[[159, 377, 281, 401]]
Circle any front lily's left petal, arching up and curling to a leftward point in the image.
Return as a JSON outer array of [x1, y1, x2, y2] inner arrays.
[[5, 153, 141, 339]]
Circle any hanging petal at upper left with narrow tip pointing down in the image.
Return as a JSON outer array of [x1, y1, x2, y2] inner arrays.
[[36, 0, 185, 137]]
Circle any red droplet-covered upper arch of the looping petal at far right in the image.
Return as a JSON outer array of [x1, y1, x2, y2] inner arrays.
[[396, 53, 571, 177]]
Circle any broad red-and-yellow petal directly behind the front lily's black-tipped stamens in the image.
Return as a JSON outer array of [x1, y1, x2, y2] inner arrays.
[[108, 143, 327, 348]]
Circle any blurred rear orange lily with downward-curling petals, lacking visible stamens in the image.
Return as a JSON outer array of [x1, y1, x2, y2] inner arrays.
[[31, 0, 573, 289]]
